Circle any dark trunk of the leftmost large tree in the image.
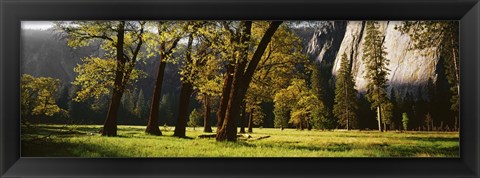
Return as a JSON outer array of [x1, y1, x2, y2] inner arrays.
[[102, 21, 126, 136]]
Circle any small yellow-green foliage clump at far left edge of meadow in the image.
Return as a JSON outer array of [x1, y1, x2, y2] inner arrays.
[[20, 74, 64, 121]]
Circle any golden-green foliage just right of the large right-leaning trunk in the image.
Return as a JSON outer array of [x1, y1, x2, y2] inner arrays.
[[245, 21, 308, 127]]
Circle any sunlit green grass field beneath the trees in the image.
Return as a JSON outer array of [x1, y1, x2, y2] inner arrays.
[[21, 125, 459, 157]]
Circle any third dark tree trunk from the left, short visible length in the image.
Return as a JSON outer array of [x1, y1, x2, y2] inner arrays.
[[173, 82, 193, 137]]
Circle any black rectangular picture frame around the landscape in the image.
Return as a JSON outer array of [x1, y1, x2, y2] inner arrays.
[[0, 0, 480, 177]]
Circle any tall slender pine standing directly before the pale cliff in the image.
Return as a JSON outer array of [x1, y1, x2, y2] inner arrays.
[[362, 21, 391, 131]]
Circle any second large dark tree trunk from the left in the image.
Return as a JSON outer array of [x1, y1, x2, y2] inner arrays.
[[145, 44, 167, 135]]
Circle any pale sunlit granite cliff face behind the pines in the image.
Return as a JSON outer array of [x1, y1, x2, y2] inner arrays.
[[307, 21, 439, 97]]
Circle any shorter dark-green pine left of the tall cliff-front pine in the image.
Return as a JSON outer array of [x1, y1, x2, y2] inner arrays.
[[333, 53, 358, 130]]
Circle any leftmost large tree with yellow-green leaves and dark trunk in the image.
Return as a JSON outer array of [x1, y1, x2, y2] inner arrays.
[[55, 21, 146, 132]]
